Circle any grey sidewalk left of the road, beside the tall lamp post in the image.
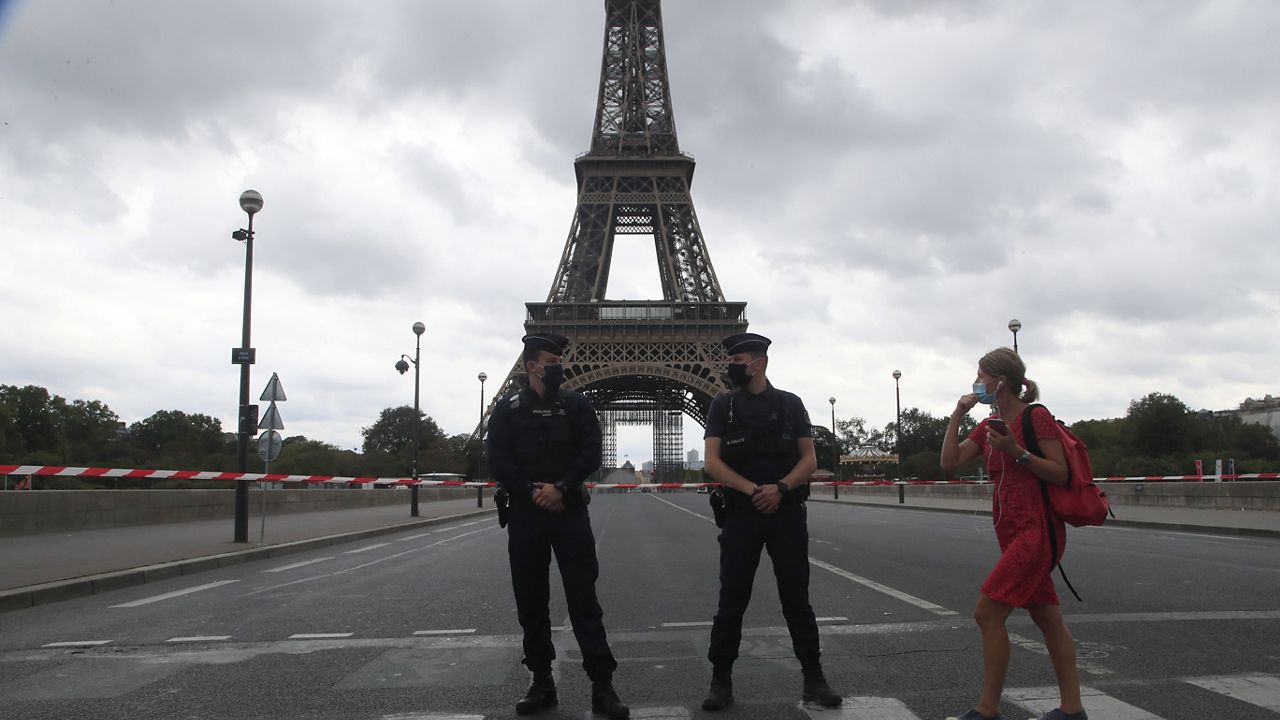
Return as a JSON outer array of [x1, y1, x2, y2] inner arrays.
[[0, 498, 497, 612]]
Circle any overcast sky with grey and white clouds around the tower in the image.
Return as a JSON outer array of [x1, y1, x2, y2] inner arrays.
[[0, 0, 1280, 461]]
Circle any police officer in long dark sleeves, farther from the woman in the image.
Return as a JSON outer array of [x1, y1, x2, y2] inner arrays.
[[489, 334, 631, 720]]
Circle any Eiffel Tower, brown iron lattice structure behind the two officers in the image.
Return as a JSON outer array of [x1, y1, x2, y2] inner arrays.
[[488, 0, 746, 482]]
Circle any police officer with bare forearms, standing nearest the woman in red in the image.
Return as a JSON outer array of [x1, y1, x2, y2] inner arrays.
[[703, 333, 842, 710]]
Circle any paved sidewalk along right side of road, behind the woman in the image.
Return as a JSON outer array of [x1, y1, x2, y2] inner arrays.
[[810, 488, 1280, 537]]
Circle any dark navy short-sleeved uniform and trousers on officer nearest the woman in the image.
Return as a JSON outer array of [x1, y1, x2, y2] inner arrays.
[[705, 384, 819, 671]]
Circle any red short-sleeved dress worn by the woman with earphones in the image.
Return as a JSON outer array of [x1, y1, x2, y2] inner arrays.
[[969, 409, 1066, 607]]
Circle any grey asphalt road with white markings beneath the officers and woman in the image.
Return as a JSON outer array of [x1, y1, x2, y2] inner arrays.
[[0, 493, 1280, 720]]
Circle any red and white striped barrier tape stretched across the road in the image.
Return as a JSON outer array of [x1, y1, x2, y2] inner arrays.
[[0, 465, 1280, 489]]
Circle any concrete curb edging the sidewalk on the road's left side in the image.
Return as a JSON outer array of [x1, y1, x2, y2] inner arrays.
[[0, 509, 497, 612]]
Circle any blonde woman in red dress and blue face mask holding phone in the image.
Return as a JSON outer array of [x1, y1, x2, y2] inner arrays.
[[941, 347, 1088, 720]]
